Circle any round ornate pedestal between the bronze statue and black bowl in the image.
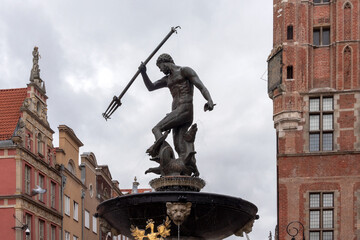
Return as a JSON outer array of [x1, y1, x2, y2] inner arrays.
[[149, 176, 206, 192]]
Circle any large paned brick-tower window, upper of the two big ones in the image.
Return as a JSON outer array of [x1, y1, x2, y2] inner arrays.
[[309, 97, 334, 152]]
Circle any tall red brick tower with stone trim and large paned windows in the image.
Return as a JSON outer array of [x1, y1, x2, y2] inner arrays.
[[268, 0, 360, 240]]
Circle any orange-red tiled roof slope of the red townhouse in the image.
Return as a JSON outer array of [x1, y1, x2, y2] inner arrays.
[[0, 88, 27, 141]]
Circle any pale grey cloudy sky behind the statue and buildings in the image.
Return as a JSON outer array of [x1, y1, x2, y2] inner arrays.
[[0, 0, 276, 240]]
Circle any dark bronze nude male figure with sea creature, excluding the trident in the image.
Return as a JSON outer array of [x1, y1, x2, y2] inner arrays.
[[139, 53, 215, 176]]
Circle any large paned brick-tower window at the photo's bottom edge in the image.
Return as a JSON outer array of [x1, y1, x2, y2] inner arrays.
[[309, 193, 334, 240]]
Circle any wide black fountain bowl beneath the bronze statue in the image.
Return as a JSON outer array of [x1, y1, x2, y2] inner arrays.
[[97, 191, 258, 240]]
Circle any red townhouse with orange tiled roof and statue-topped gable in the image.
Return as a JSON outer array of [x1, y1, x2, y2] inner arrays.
[[0, 47, 62, 240]]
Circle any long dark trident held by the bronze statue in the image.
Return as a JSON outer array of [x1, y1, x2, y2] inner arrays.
[[102, 26, 181, 121]]
